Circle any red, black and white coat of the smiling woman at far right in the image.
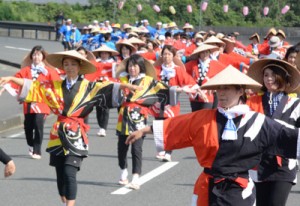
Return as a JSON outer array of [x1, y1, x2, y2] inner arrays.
[[247, 93, 300, 183]]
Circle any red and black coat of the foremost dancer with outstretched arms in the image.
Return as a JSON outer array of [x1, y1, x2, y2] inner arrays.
[[153, 110, 300, 206]]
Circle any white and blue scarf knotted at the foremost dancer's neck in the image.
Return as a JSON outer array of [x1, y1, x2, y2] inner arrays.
[[218, 104, 250, 140]]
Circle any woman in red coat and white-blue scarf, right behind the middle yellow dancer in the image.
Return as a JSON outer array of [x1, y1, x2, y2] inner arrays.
[[154, 45, 206, 162]]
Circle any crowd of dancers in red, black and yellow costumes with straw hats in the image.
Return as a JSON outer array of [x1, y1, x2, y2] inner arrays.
[[0, 24, 300, 206]]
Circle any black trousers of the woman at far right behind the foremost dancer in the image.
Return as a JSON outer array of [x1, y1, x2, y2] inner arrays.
[[255, 181, 293, 206]]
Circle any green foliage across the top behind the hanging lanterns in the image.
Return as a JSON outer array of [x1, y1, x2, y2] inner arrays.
[[0, 0, 300, 27]]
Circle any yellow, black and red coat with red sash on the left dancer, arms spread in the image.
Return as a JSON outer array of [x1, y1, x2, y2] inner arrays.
[[20, 77, 123, 157]]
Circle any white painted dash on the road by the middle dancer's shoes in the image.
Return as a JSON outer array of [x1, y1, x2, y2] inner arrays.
[[111, 162, 179, 195]]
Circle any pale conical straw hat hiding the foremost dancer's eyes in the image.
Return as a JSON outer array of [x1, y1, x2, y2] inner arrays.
[[201, 65, 262, 90]]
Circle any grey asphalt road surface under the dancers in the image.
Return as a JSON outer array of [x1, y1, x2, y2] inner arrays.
[[0, 37, 300, 206]]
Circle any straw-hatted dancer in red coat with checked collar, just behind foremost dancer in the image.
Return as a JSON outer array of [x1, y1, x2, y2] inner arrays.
[[185, 44, 226, 112]]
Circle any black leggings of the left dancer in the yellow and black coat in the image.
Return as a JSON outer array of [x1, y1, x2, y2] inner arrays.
[[50, 155, 82, 200]]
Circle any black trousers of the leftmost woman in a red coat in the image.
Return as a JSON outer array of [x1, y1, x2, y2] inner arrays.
[[24, 113, 47, 155]]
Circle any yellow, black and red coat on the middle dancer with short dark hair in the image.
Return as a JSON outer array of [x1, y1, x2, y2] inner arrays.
[[116, 75, 174, 135]]
